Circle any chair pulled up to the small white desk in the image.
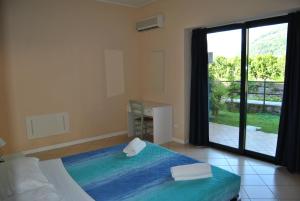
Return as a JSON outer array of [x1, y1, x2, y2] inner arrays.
[[129, 100, 153, 139]]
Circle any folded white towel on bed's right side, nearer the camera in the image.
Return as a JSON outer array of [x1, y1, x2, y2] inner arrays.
[[171, 163, 212, 181]]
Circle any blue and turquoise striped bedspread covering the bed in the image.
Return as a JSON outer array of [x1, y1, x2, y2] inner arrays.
[[62, 143, 240, 201]]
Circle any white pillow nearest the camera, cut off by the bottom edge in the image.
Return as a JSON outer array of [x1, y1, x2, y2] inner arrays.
[[4, 184, 62, 201]]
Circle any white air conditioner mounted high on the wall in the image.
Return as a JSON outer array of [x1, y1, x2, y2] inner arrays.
[[136, 15, 164, 31]]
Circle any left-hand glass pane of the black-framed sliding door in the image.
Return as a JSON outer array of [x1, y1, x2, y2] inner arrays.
[[207, 29, 242, 148]]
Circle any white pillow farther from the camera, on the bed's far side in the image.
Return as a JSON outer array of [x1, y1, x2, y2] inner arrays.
[[7, 157, 49, 194]]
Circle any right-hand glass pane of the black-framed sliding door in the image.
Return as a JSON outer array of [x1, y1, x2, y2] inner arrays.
[[245, 23, 287, 156]]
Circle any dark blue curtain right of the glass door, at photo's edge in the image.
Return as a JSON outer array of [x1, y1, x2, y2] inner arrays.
[[276, 12, 300, 172]]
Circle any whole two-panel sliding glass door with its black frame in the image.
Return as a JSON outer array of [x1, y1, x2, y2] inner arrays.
[[207, 18, 287, 159]]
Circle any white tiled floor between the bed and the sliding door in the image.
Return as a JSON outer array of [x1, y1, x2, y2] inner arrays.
[[165, 143, 300, 201]]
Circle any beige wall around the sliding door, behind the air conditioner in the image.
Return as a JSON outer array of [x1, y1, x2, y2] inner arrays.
[[136, 0, 300, 140]]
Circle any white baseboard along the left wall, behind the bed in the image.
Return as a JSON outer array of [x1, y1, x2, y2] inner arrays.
[[22, 131, 128, 155]]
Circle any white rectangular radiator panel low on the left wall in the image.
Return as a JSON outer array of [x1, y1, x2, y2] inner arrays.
[[26, 112, 70, 139]]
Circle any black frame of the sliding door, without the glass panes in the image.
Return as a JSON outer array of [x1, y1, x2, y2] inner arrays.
[[207, 15, 289, 163]]
